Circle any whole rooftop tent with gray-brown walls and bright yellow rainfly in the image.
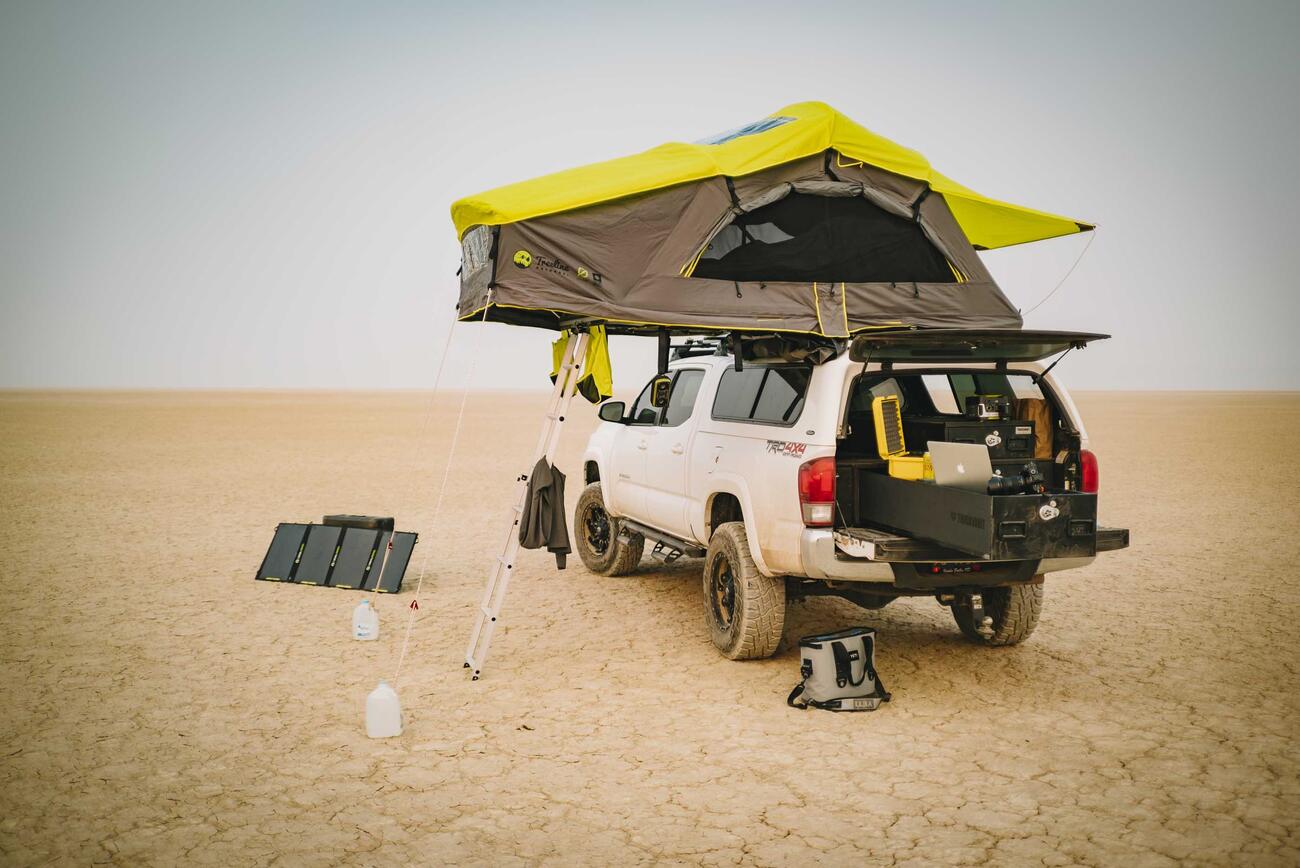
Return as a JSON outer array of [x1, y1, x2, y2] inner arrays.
[[451, 103, 1092, 338]]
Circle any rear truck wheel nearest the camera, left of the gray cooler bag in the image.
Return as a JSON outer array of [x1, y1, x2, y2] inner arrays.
[[705, 521, 785, 660]]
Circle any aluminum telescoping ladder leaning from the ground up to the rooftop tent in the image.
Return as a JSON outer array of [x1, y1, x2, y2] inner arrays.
[[465, 331, 590, 681]]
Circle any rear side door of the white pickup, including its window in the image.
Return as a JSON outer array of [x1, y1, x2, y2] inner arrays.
[[642, 368, 705, 538]]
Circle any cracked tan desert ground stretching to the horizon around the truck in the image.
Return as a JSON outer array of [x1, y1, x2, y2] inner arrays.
[[0, 392, 1300, 865]]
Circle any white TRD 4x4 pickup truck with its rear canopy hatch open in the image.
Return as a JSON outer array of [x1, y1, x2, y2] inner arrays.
[[573, 329, 1128, 659]]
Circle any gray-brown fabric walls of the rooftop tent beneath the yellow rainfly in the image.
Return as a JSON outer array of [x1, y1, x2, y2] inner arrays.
[[459, 151, 1022, 338]]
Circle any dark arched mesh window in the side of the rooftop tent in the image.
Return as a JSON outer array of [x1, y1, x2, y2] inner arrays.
[[690, 192, 957, 283]]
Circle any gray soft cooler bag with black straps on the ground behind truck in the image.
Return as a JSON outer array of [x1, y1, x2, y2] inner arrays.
[[785, 626, 889, 711]]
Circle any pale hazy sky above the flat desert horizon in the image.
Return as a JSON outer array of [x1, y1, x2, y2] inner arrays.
[[0, 1, 1300, 391]]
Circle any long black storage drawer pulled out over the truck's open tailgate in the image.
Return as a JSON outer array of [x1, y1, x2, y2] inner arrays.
[[857, 472, 1097, 560]]
